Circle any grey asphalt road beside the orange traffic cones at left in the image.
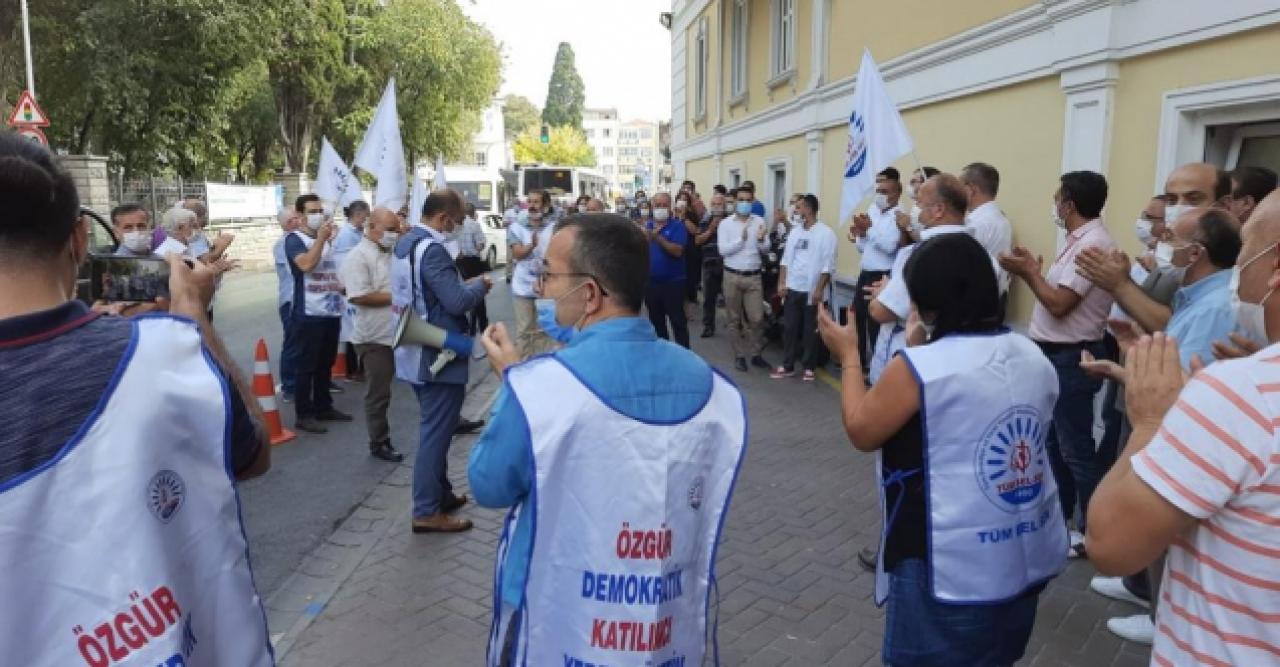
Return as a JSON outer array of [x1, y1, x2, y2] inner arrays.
[[214, 265, 513, 598]]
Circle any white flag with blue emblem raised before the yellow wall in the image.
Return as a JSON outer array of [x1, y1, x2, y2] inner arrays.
[[840, 49, 914, 223]]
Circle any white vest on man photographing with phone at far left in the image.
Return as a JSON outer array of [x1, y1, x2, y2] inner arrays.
[[0, 316, 274, 667]]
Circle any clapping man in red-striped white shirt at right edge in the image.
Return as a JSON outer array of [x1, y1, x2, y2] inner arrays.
[[1087, 193, 1280, 666]]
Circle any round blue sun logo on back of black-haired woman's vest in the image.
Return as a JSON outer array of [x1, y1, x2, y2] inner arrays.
[[974, 406, 1048, 513]]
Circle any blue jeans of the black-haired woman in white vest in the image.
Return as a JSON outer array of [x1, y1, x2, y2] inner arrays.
[[881, 558, 1039, 667]]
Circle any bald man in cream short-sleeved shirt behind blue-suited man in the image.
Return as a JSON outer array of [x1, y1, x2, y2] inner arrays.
[[339, 206, 404, 463]]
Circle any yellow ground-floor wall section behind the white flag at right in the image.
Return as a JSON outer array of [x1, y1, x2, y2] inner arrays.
[[822, 77, 1065, 320]]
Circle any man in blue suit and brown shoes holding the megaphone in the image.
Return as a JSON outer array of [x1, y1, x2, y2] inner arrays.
[[392, 189, 492, 533]]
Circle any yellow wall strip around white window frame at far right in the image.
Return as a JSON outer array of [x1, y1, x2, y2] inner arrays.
[[1107, 28, 1280, 252]]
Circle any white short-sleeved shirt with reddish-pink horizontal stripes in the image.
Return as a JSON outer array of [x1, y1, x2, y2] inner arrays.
[[1132, 344, 1280, 666]]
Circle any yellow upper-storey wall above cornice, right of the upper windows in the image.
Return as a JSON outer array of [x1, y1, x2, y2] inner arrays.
[[824, 0, 1039, 81]]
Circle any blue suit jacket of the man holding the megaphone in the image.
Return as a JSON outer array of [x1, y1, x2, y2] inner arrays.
[[394, 225, 485, 384]]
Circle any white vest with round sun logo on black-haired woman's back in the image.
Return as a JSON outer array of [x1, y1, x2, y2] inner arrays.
[[885, 332, 1068, 604]]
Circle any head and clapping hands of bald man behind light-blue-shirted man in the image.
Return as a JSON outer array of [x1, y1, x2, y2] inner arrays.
[[1075, 163, 1231, 332]]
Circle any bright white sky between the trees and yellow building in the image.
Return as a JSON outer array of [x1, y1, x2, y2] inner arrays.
[[457, 0, 672, 120]]
